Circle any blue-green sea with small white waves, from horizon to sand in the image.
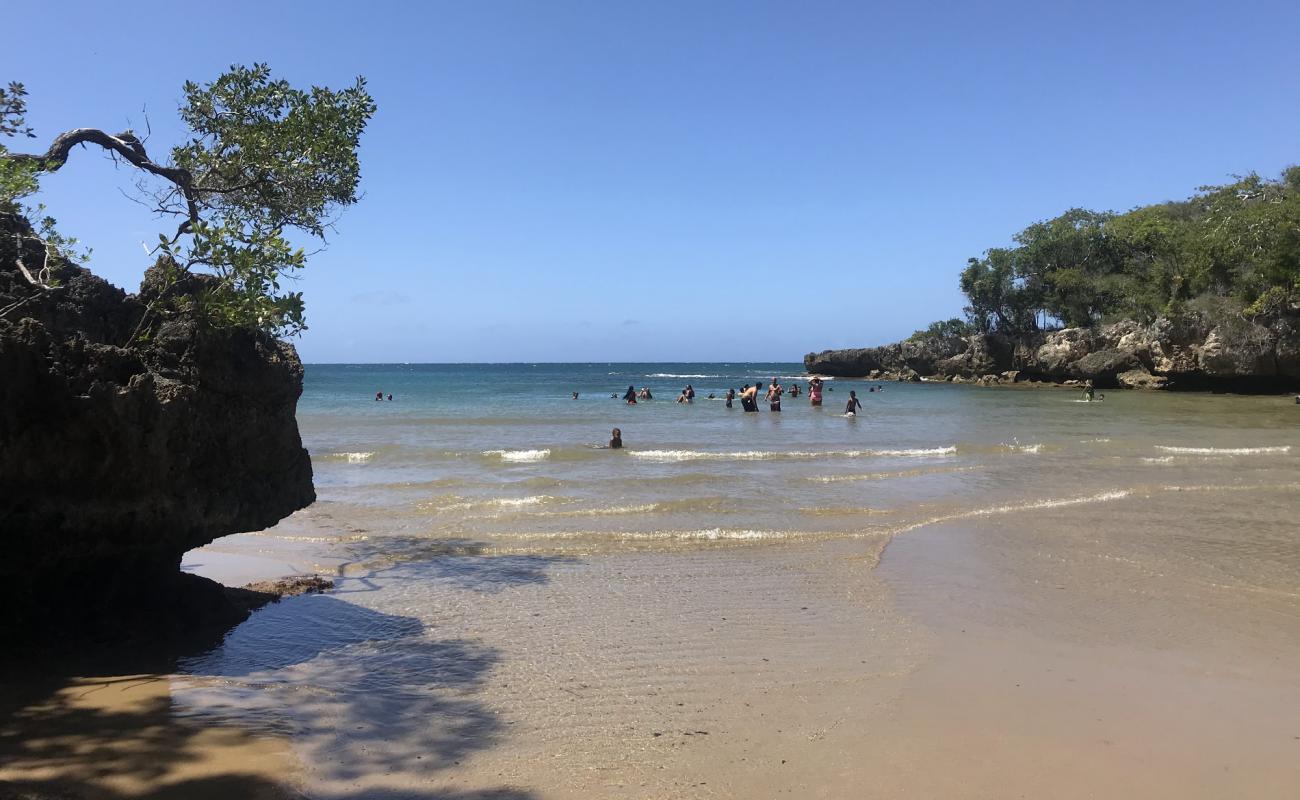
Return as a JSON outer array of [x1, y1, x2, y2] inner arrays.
[[281, 363, 1300, 549]]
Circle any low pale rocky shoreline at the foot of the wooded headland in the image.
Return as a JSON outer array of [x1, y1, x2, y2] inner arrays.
[[803, 310, 1300, 392]]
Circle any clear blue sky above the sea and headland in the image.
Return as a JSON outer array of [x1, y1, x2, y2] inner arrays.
[[0, 0, 1300, 362]]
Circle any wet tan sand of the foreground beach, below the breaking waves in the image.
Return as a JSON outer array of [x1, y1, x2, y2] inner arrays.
[[0, 488, 1300, 799]]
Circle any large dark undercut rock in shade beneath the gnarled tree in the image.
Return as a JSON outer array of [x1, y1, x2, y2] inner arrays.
[[0, 215, 315, 645]]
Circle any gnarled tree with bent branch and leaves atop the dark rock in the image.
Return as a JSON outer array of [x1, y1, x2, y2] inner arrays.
[[0, 64, 376, 334]]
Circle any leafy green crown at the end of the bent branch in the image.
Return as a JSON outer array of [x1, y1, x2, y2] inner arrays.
[[160, 64, 376, 336]]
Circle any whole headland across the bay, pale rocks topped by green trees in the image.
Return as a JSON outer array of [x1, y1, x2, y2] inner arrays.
[[803, 167, 1300, 392]]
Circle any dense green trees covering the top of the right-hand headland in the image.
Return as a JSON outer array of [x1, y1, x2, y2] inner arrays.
[[961, 167, 1300, 333]]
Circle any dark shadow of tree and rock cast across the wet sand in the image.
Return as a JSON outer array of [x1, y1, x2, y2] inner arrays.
[[0, 542, 574, 800]]
